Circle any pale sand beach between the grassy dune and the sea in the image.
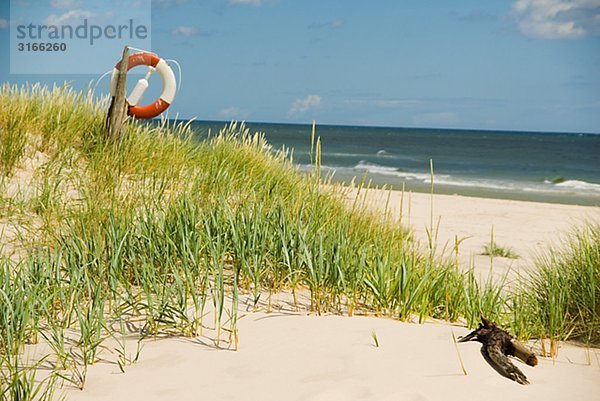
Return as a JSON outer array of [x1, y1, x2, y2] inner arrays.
[[347, 190, 600, 278]]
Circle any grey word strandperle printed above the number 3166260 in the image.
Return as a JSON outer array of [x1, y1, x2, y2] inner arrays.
[[16, 18, 148, 45]]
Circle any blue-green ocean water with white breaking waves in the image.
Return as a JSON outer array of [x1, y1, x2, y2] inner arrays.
[[192, 121, 600, 205]]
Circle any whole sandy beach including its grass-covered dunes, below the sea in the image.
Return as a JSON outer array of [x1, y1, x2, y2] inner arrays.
[[0, 86, 600, 401]]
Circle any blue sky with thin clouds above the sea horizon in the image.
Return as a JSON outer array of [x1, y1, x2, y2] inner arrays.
[[0, 0, 600, 133]]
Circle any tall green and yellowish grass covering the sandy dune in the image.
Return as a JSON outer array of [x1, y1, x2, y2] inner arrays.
[[0, 85, 600, 400]]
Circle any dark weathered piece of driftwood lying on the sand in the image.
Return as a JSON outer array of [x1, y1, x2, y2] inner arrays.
[[458, 316, 538, 384]]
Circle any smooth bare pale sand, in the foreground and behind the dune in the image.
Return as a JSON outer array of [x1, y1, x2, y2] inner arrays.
[[59, 190, 600, 401]]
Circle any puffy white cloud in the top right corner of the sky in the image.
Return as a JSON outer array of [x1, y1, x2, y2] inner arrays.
[[513, 0, 600, 39]]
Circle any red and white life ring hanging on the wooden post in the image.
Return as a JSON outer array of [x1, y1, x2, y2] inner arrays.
[[110, 52, 177, 119]]
